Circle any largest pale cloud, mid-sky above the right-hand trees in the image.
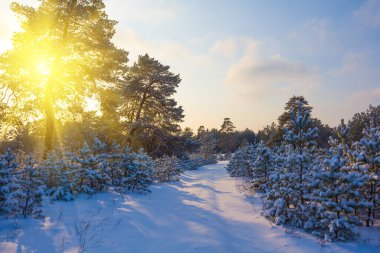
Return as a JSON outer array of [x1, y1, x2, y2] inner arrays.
[[226, 41, 318, 100]]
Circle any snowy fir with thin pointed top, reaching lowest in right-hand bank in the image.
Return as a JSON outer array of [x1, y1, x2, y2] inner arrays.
[[305, 120, 365, 240]]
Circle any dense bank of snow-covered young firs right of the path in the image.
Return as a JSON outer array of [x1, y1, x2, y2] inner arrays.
[[228, 100, 380, 241]]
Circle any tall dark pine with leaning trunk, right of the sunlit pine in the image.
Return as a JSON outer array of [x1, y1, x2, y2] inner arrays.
[[120, 54, 184, 155]]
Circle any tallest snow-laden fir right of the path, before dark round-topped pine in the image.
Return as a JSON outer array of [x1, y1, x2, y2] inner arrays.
[[265, 101, 318, 227]]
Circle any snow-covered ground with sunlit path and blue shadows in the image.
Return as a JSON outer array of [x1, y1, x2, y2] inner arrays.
[[0, 163, 380, 253]]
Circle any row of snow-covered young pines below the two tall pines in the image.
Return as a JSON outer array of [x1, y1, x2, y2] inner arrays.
[[42, 139, 157, 200]]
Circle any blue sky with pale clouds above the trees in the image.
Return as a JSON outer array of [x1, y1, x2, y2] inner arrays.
[[0, 0, 380, 130]]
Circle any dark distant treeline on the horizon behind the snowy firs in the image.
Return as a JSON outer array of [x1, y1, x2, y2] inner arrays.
[[185, 96, 380, 158]]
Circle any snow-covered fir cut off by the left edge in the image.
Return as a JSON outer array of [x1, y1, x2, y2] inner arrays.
[[0, 150, 20, 215]]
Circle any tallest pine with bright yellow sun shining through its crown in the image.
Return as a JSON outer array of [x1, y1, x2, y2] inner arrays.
[[0, 0, 128, 157]]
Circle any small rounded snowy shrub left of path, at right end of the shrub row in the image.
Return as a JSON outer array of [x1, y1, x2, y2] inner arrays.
[[153, 156, 183, 182]]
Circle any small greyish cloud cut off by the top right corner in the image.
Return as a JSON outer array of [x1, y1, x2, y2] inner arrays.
[[354, 0, 380, 27]]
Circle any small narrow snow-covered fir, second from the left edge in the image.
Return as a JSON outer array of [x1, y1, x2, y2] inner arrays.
[[18, 156, 44, 218]]
